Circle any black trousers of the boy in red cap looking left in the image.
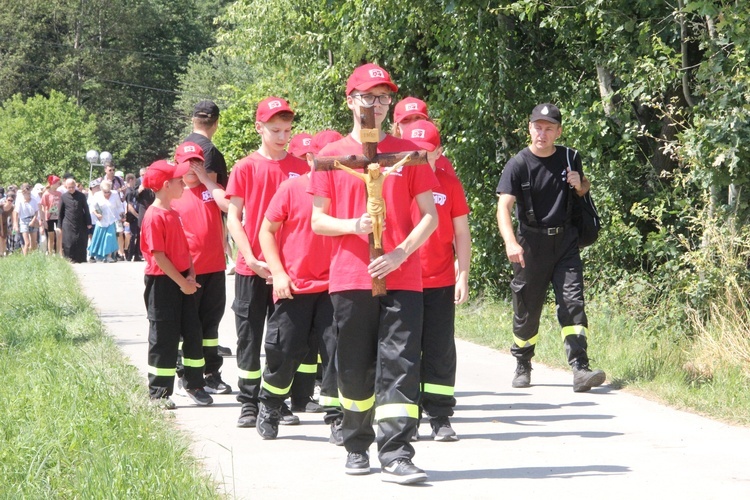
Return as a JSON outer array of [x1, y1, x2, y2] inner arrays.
[[232, 274, 274, 404]]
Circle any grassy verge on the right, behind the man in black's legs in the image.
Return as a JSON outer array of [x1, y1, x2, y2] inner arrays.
[[456, 290, 750, 426]]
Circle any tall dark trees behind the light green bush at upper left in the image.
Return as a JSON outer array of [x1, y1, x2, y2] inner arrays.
[[0, 0, 222, 176]]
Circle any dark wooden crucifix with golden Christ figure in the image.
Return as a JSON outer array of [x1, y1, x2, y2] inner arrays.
[[308, 106, 428, 296]]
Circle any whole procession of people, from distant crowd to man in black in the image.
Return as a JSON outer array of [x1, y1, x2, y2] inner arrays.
[[2, 64, 605, 484]]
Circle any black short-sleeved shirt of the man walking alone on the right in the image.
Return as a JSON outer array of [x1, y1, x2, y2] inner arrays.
[[496, 146, 582, 227]]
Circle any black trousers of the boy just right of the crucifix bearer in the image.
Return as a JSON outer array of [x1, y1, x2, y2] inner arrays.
[[420, 285, 456, 417]]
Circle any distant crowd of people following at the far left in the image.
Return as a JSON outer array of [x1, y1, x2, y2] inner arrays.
[[0, 164, 153, 263]]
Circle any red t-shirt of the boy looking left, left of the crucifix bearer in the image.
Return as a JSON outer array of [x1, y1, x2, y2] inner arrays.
[[226, 151, 310, 276]]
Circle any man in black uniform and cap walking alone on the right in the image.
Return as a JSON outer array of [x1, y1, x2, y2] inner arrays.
[[497, 103, 606, 392]]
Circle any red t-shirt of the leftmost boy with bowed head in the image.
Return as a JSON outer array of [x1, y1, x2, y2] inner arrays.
[[141, 205, 190, 276]]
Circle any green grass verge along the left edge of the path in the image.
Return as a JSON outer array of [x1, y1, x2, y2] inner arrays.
[[0, 254, 220, 498]]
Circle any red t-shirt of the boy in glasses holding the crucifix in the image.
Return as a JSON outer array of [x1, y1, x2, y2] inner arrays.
[[308, 134, 437, 292]]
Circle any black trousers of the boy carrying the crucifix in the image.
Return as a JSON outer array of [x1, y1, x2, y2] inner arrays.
[[331, 290, 422, 466]]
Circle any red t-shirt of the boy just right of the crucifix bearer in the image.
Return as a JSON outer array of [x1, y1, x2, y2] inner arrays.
[[412, 168, 469, 288]]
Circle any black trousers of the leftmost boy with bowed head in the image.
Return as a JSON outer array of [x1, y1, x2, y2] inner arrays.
[[143, 275, 205, 398]]
